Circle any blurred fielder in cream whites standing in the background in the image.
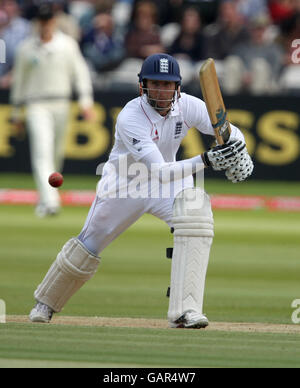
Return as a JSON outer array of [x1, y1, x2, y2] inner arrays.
[[11, 3, 93, 217]]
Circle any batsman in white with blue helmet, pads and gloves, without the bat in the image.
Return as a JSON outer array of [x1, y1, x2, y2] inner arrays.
[[30, 54, 253, 328]]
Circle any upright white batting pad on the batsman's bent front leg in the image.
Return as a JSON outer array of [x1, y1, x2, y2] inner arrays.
[[168, 188, 214, 322]]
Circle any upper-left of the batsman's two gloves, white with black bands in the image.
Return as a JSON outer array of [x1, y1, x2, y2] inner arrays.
[[203, 140, 247, 171]]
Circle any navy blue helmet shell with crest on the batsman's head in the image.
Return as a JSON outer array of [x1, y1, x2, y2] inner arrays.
[[138, 54, 181, 85]]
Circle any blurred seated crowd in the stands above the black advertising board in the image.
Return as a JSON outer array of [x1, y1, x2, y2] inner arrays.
[[0, 0, 300, 95]]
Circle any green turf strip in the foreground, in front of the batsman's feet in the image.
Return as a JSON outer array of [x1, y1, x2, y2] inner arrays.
[[0, 324, 300, 368]]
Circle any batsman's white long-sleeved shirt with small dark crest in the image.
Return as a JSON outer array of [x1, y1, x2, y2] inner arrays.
[[97, 93, 244, 197]]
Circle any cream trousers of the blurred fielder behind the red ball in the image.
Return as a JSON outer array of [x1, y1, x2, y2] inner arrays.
[[26, 100, 70, 208]]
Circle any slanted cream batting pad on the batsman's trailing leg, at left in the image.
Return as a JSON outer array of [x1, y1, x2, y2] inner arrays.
[[34, 238, 100, 313]]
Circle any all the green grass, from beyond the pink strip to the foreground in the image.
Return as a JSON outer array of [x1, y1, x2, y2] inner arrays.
[[0, 174, 300, 367]]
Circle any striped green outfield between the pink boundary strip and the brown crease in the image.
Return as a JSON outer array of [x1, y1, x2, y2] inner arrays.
[[0, 206, 300, 323]]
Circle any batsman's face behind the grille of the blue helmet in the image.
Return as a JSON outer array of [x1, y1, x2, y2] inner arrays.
[[147, 79, 176, 116]]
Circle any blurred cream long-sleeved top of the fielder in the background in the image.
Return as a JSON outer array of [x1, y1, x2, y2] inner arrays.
[[11, 31, 93, 113]]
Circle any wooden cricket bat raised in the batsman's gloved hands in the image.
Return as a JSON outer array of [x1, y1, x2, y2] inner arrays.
[[199, 58, 231, 144]]
